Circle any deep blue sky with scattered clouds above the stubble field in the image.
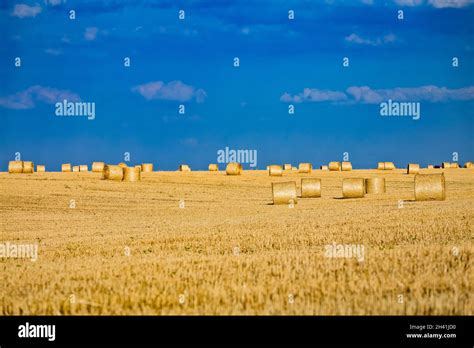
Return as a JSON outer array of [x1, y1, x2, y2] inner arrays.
[[0, 0, 474, 170]]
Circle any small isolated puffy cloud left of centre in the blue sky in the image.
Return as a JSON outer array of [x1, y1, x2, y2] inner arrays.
[[132, 81, 207, 103]]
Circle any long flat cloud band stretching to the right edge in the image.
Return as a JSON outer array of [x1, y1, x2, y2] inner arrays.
[[280, 85, 474, 104]]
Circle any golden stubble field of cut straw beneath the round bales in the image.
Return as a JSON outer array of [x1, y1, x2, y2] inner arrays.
[[0, 169, 474, 315]]
